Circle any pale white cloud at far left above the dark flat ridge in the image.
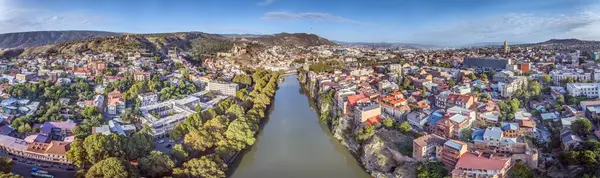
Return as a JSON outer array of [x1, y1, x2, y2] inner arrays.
[[0, 0, 104, 33]]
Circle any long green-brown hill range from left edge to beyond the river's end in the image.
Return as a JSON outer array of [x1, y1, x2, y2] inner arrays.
[[0, 32, 335, 58]]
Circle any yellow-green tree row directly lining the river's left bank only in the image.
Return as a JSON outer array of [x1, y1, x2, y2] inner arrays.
[[169, 69, 280, 177]]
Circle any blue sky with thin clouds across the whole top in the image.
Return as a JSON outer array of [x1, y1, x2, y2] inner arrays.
[[0, 0, 600, 46]]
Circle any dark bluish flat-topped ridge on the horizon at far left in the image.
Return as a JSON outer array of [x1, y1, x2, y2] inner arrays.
[[0, 31, 121, 49]]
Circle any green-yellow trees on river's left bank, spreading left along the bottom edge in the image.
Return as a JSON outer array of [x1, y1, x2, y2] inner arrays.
[[67, 68, 283, 177]]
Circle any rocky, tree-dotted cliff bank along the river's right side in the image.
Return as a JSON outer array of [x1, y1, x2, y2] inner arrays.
[[298, 71, 417, 177]]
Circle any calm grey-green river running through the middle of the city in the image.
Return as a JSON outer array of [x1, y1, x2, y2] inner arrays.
[[231, 75, 370, 178]]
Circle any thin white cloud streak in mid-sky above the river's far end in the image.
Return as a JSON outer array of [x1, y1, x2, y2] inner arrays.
[[263, 12, 364, 24]]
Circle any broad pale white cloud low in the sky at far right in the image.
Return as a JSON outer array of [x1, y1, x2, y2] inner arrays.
[[413, 8, 600, 45]]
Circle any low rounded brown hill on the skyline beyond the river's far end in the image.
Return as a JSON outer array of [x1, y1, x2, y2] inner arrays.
[[241, 33, 337, 47]]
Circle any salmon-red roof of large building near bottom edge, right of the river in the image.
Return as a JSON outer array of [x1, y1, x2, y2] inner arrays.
[[456, 153, 510, 170]]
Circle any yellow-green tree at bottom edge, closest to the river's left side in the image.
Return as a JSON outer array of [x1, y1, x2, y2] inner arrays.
[[173, 155, 227, 178]]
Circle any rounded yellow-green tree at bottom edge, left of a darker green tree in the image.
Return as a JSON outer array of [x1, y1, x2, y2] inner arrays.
[[85, 157, 140, 178]]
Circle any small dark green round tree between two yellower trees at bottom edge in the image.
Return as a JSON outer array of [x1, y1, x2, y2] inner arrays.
[[138, 151, 175, 177]]
